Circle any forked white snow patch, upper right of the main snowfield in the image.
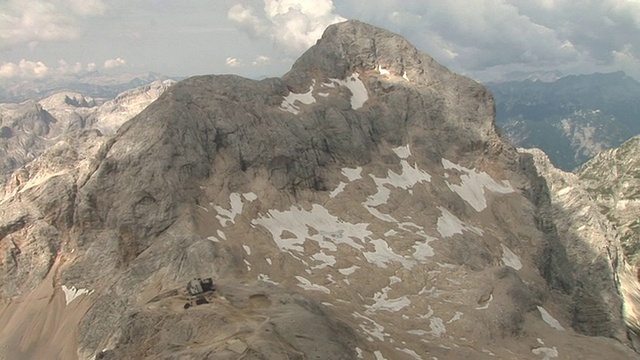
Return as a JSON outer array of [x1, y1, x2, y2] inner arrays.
[[442, 158, 515, 211]]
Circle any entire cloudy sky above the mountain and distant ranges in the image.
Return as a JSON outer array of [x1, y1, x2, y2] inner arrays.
[[0, 0, 640, 81]]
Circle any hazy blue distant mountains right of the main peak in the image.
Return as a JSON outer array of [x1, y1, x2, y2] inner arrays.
[[486, 72, 640, 171]]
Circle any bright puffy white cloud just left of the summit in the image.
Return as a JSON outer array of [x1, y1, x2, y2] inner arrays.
[[228, 0, 346, 53]]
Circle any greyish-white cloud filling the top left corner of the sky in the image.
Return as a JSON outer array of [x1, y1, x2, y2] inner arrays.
[[0, 0, 106, 47]]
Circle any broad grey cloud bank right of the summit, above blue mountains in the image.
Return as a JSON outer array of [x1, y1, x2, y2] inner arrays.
[[334, 0, 640, 79]]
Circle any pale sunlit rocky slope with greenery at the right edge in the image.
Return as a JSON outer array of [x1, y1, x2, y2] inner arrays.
[[521, 137, 640, 346]]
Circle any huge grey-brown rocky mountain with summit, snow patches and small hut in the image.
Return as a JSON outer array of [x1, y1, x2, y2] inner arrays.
[[0, 21, 637, 360]]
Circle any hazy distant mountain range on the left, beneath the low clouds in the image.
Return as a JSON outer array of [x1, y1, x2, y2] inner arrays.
[[0, 71, 181, 103]]
